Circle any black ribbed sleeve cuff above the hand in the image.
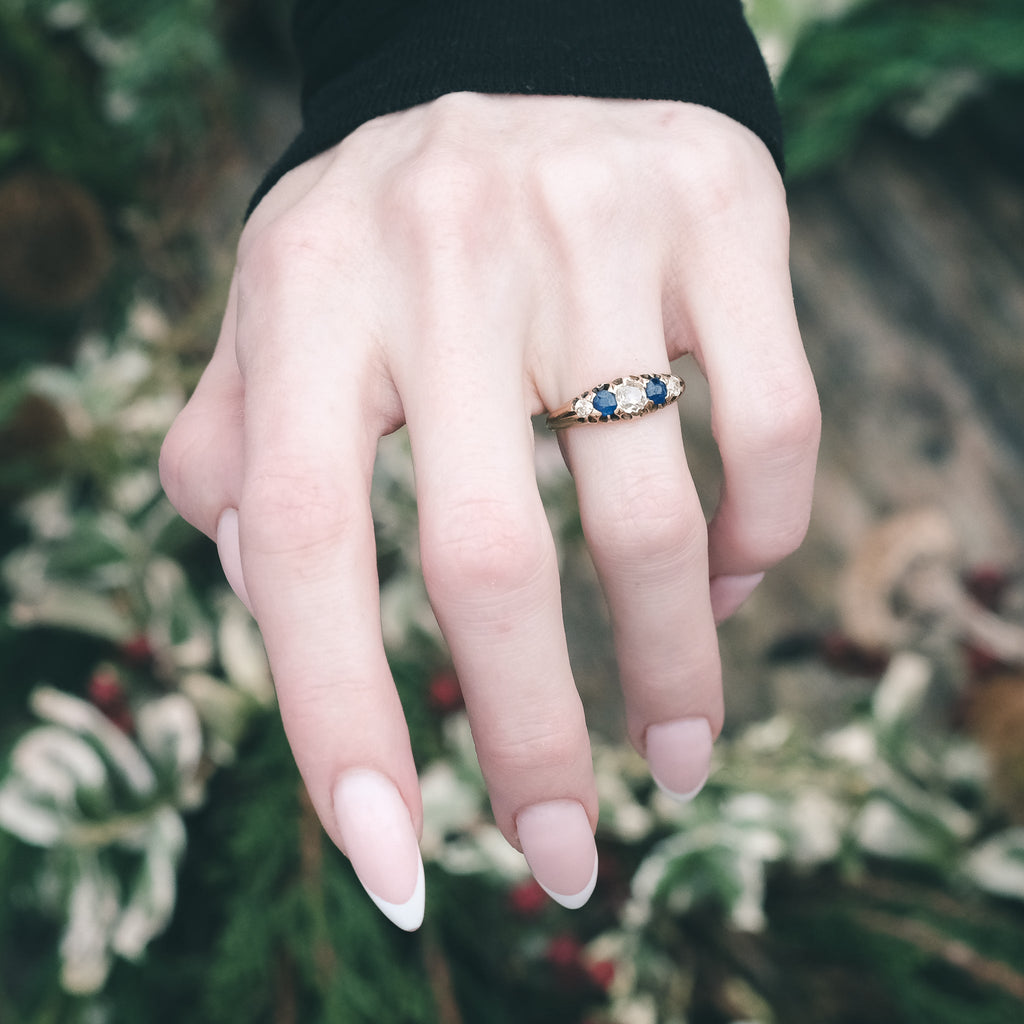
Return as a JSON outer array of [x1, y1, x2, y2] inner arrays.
[[250, 0, 782, 209]]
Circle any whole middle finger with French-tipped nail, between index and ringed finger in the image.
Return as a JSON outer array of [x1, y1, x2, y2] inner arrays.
[[397, 325, 597, 906]]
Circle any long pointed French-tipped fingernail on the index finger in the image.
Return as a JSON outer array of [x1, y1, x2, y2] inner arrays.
[[334, 768, 425, 932]]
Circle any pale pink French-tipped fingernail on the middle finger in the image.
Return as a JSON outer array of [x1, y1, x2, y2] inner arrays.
[[516, 800, 597, 910]]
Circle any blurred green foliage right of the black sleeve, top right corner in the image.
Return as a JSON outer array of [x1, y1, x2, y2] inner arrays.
[[778, 0, 1024, 177]]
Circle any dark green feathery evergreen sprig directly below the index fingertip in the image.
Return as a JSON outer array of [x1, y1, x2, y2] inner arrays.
[[188, 716, 434, 1024]]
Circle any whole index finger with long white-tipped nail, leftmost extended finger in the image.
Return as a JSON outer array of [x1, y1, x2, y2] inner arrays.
[[238, 237, 424, 929]]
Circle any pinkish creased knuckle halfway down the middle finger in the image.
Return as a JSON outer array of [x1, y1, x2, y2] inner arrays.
[[422, 499, 552, 601]]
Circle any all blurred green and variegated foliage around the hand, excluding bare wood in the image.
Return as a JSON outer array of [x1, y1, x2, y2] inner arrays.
[[0, 0, 1024, 1024]]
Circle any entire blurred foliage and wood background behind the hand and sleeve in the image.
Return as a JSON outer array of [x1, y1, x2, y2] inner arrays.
[[0, 0, 1024, 1024]]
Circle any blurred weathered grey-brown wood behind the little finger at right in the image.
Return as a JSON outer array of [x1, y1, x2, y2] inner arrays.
[[567, 117, 1024, 733]]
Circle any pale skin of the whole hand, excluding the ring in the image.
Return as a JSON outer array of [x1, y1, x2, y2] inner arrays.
[[155, 93, 819, 928]]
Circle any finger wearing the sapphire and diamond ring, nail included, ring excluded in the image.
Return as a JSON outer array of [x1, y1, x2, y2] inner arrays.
[[560, 331, 723, 799]]
